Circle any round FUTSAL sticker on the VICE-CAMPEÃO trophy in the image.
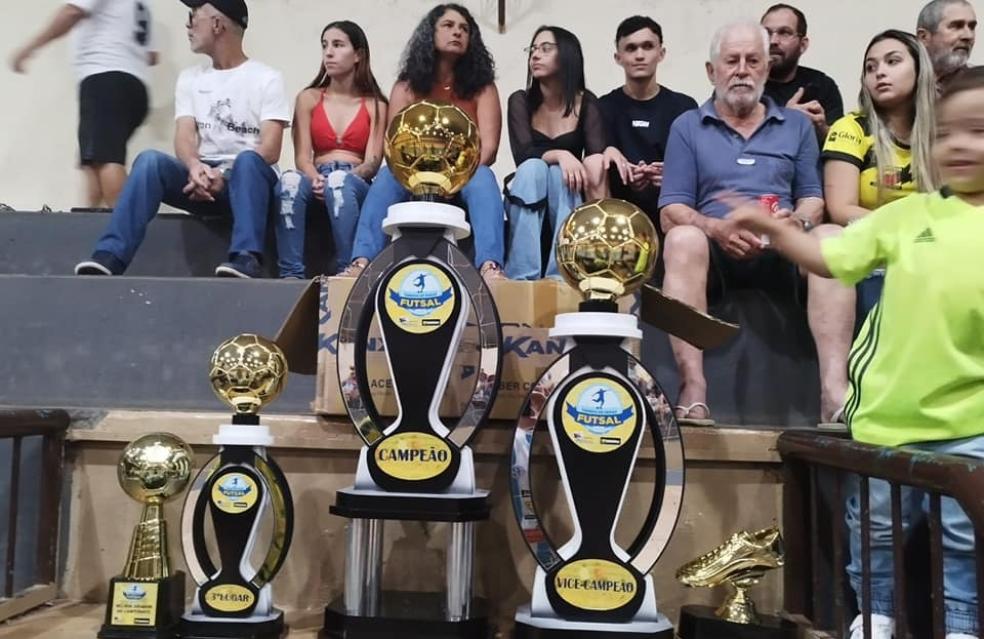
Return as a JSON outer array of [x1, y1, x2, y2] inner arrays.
[[560, 377, 638, 453]]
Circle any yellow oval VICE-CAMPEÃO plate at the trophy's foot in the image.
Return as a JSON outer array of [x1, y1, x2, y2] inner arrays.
[[554, 559, 639, 610]]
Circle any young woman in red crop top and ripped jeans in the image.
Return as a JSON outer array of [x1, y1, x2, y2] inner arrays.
[[277, 20, 386, 278]]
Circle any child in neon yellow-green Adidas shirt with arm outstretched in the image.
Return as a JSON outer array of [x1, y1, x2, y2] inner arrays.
[[729, 67, 984, 639]]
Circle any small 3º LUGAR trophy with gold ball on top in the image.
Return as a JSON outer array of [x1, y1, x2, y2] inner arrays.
[[180, 333, 294, 639]]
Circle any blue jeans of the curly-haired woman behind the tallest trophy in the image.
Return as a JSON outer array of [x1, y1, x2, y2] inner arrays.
[[352, 164, 505, 267]]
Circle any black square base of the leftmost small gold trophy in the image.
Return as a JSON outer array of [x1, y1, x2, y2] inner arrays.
[[96, 571, 185, 639]]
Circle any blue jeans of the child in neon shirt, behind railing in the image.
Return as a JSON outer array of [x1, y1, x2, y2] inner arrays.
[[846, 436, 984, 635]]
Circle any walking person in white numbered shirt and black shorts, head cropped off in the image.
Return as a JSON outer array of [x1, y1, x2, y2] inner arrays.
[[10, 0, 157, 206]]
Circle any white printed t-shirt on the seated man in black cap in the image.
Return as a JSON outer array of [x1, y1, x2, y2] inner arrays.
[[174, 60, 290, 169]]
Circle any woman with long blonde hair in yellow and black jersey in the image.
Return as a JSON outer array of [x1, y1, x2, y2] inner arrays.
[[820, 29, 938, 323]]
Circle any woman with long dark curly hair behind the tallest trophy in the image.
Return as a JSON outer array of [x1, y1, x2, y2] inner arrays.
[[344, 4, 505, 280]]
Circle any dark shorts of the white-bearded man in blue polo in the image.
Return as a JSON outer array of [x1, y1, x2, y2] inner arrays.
[[707, 238, 806, 303]]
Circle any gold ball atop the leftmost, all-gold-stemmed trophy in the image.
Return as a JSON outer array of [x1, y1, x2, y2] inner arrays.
[[116, 433, 192, 503]]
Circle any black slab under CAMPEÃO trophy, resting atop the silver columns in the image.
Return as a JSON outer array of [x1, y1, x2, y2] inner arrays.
[[329, 490, 491, 522]]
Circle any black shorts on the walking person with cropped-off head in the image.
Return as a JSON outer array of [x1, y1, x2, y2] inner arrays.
[[79, 71, 147, 164]]
